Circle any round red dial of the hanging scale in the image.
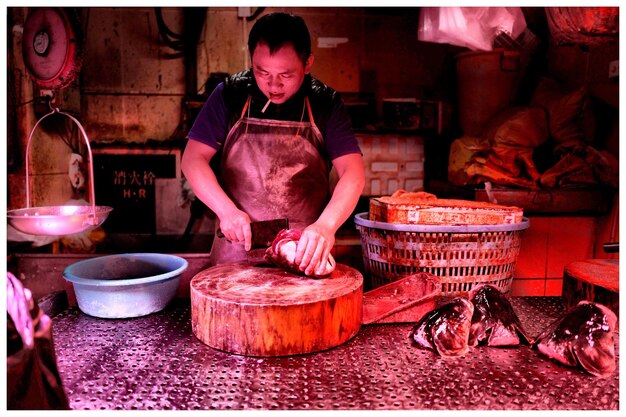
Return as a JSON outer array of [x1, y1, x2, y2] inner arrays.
[[22, 7, 82, 90]]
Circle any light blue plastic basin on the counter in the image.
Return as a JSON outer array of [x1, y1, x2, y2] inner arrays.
[[63, 253, 188, 318]]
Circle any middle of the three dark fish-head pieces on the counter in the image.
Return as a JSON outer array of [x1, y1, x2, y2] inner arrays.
[[468, 284, 530, 346]]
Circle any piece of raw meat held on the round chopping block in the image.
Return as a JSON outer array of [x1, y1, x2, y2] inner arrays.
[[265, 229, 335, 278]]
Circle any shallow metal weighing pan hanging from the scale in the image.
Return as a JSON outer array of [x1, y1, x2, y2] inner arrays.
[[7, 206, 113, 236]]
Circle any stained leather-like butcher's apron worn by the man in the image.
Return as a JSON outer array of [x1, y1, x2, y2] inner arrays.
[[210, 97, 329, 265]]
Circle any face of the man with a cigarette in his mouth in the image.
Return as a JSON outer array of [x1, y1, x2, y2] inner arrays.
[[252, 42, 313, 104]]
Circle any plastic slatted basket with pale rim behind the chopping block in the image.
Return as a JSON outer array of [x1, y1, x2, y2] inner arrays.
[[354, 213, 530, 296]]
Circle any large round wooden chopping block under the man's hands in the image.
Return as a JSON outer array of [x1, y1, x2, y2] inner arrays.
[[190, 261, 363, 356]]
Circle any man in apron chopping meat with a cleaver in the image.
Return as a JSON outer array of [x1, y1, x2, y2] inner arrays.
[[182, 13, 365, 275]]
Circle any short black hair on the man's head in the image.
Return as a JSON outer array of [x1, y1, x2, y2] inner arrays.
[[248, 12, 311, 65]]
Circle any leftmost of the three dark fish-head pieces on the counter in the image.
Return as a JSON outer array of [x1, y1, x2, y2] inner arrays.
[[411, 297, 474, 359]]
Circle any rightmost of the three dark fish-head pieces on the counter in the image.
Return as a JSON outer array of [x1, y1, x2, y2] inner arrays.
[[534, 301, 617, 378]]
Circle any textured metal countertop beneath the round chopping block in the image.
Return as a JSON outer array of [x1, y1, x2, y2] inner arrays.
[[53, 297, 619, 410]]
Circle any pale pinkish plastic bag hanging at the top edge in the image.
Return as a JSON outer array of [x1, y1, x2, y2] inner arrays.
[[417, 6, 526, 51]]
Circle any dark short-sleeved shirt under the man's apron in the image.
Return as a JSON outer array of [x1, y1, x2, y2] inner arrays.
[[187, 73, 361, 161]]
